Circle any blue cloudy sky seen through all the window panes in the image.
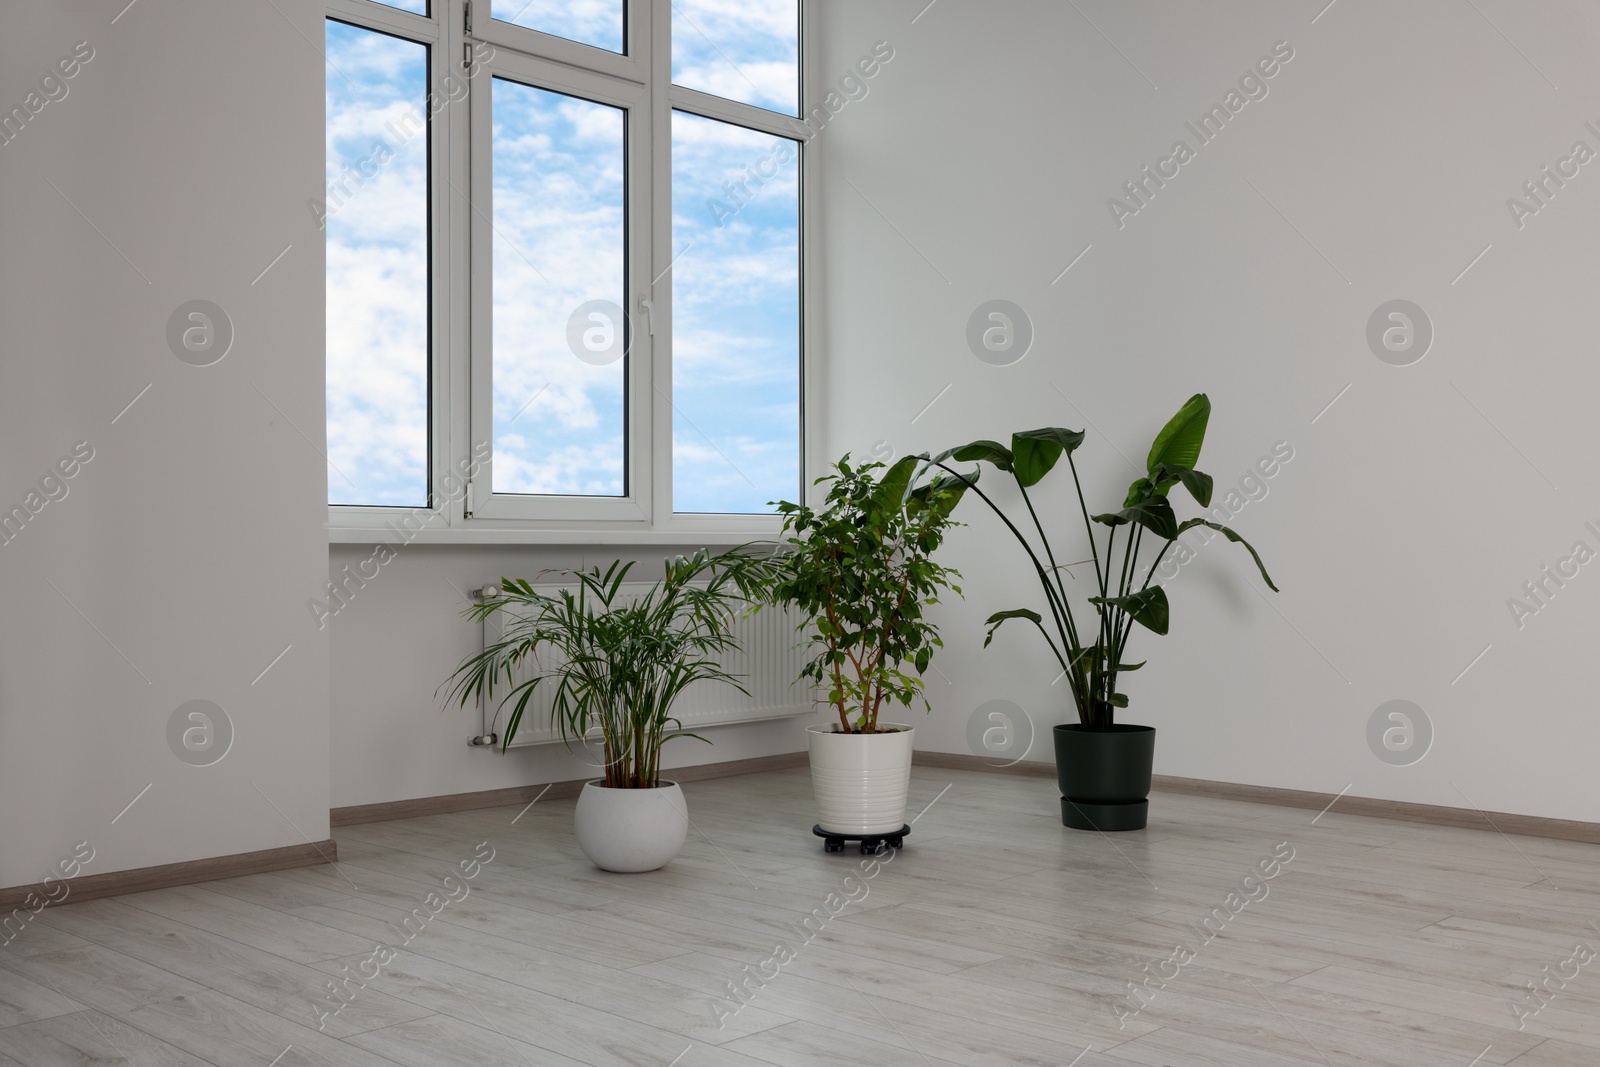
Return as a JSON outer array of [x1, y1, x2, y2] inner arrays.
[[326, 0, 800, 512]]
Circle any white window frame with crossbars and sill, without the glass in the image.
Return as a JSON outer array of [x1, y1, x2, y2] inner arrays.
[[326, 0, 822, 544]]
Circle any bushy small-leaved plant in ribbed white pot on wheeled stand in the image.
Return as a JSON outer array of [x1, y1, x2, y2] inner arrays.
[[770, 454, 966, 848]]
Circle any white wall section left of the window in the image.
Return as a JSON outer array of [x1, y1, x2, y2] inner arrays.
[[0, 0, 328, 886]]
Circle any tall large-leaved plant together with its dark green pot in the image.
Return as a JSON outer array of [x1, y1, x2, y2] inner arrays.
[[933, 394, 1278, 830]]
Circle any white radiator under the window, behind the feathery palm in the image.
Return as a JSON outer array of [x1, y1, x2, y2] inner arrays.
[[483, 582, 816, 749]]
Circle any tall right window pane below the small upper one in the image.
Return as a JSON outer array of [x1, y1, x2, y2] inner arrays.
[[672, 112, 800, 514]]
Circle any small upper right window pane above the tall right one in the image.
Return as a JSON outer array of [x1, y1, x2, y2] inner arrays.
[[672, 0, 800, 115]]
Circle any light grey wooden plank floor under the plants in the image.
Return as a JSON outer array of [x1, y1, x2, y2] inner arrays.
[[0, 768, 1600, 1067]]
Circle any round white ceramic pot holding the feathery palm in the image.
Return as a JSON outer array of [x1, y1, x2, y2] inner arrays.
[[573, 781, 690, 873]]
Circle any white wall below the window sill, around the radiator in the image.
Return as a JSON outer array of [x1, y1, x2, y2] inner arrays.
[[332, 544, 810, 808]]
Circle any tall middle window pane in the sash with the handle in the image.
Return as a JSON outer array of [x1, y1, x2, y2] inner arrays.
[[493, 78, 629, 496]]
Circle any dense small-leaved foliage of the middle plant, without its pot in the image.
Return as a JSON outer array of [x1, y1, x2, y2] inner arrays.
[[770, 454, 966, 733]]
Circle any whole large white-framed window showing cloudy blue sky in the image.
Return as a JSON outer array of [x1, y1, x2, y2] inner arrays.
[[323, 0, 810, 541]]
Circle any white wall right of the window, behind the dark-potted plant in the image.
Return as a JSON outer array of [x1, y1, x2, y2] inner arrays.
[[822, 0, 1600, 821]]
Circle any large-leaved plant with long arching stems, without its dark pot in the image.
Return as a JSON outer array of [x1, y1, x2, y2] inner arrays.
[[931, 394, 1278, 731]]
